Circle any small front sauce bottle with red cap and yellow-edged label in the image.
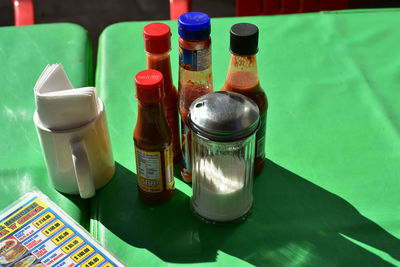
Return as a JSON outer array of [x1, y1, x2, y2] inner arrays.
[[133, 70, 175, 204]]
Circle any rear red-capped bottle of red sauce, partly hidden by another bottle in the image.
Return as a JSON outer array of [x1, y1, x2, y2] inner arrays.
[[143, 22, 181, 163]]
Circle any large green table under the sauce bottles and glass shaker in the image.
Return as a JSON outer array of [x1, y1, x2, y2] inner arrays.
[[94, 9, 400, 266]]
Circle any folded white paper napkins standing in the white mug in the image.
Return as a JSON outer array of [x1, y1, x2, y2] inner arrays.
[[34, 64, 98, 130]]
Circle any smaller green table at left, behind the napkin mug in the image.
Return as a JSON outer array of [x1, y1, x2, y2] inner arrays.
[[0, 24, 93, 227]]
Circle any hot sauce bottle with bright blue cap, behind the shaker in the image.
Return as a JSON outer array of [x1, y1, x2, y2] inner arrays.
[[178, 12, 213, 182]]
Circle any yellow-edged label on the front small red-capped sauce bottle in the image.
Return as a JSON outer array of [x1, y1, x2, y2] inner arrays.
[[135, 145, 174, 193]]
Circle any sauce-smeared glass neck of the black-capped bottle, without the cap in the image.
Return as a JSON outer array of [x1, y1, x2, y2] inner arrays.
[[225, 53, 259, 90]]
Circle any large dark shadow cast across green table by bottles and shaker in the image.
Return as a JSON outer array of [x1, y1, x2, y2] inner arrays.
[[97, 161, 400, 266]]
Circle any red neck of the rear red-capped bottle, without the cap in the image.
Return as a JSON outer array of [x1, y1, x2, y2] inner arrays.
[[146, 51, 173, 91]]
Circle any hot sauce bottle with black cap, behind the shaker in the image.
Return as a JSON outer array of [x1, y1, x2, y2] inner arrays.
[[221, 23, 268, 175]]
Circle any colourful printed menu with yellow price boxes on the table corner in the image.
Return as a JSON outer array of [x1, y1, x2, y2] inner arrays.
[[0, 192, 125, 267]]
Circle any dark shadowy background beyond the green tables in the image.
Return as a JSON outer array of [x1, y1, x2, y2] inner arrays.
[[0, 0, 400, 62]]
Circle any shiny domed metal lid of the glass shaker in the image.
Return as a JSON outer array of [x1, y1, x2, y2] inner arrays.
[[188, 91, 260, 142]]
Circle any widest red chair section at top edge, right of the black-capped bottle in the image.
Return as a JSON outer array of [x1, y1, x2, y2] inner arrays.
[[236, 0, 348, 16]]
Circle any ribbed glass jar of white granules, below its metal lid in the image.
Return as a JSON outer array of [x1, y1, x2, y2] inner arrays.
[[191, 132, 255, 222]]
